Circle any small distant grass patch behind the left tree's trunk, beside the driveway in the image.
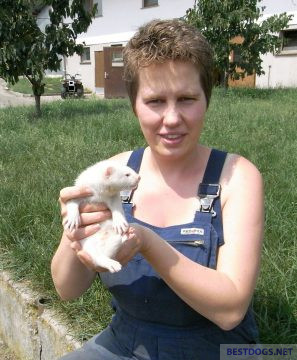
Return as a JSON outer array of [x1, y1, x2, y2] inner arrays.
[[8, 77, 62, 95]]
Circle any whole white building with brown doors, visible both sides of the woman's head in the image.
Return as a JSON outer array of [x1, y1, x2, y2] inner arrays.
[[55, 0, 297, 93]]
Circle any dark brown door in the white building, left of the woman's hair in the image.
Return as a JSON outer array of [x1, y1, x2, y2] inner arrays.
[[103, 46, 127, 98]]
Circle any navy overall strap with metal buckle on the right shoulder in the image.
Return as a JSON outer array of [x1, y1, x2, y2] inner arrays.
[[197, 149, 227, 244]]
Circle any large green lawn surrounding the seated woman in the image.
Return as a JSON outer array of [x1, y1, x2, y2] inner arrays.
[[0, 89, 297, 344]]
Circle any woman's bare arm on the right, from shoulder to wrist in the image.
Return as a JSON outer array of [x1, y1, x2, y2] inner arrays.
[[135, 158, 263, 330]]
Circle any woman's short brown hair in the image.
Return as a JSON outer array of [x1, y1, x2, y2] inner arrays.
[[124, 19, 213, 109]]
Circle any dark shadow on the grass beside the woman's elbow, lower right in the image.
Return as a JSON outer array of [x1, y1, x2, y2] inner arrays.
[[253, 291, 297, 344]]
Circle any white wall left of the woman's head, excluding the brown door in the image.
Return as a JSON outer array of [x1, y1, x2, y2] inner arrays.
[[66, 0, 194, 93]]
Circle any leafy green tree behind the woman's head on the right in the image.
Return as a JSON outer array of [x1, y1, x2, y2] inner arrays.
[[185, 0, 291, 88]]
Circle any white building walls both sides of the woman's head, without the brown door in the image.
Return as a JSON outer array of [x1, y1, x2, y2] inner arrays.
[[66, 0, 297, 93]]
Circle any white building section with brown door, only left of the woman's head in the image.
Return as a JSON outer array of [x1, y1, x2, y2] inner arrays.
[[66, 0, 194, 97]]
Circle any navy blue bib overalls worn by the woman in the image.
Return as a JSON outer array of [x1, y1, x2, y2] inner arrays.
[[63, 148, 258, 360]]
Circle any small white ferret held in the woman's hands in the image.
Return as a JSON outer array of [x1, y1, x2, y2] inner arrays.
[[64, 160, 140, 273]]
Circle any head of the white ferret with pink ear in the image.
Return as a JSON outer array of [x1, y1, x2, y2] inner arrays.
[[103, 164, 140, 192]]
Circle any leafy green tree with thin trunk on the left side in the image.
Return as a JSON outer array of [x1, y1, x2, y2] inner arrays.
[[0, 0, 96, 115]]
